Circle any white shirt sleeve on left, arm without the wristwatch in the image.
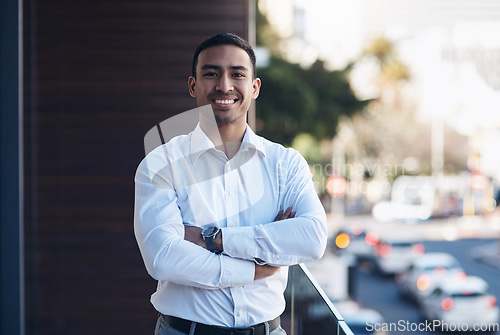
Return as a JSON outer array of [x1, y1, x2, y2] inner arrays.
[[134, 154, 255, 289]]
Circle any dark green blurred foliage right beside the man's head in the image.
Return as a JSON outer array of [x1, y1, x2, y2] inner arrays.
[[256, 57, 367, 146]]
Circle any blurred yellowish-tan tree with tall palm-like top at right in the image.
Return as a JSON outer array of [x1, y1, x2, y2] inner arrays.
[[340, 37, 465, 179]]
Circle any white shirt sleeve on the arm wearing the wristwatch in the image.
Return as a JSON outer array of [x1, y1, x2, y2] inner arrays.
[[222, 149, 328, 266]]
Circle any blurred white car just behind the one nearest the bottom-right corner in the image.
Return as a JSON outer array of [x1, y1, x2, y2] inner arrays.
[[396, 252, 466, 303]]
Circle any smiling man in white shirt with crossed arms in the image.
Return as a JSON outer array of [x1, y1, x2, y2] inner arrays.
[[134, 34, 327, 335]]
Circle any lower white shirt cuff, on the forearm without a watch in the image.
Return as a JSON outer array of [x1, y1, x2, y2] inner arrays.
[[221, 256, 255, 288]]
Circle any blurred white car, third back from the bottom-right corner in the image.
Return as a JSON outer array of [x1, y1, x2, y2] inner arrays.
[[373, 238, 424, 275]]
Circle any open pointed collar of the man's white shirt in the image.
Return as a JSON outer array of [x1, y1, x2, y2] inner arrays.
[[190, 123, 266, 163]]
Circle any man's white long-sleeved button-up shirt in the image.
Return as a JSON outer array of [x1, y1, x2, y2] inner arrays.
[[134, 125, 327, 327]]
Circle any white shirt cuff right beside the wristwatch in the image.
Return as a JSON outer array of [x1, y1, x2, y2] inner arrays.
[[221, 226, 257, 260]]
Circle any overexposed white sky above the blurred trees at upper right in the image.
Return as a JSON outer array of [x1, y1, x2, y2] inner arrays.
[[290, 0, 500, 129]]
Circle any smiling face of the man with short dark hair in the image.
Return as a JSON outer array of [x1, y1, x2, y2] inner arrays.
[[188, 45, 260, 125]]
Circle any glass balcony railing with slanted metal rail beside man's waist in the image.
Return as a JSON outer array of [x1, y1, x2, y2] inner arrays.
[[281, 264, 354, 335]]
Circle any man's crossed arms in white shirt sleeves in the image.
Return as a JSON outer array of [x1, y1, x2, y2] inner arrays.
[[134, 146, 327, 289]]
